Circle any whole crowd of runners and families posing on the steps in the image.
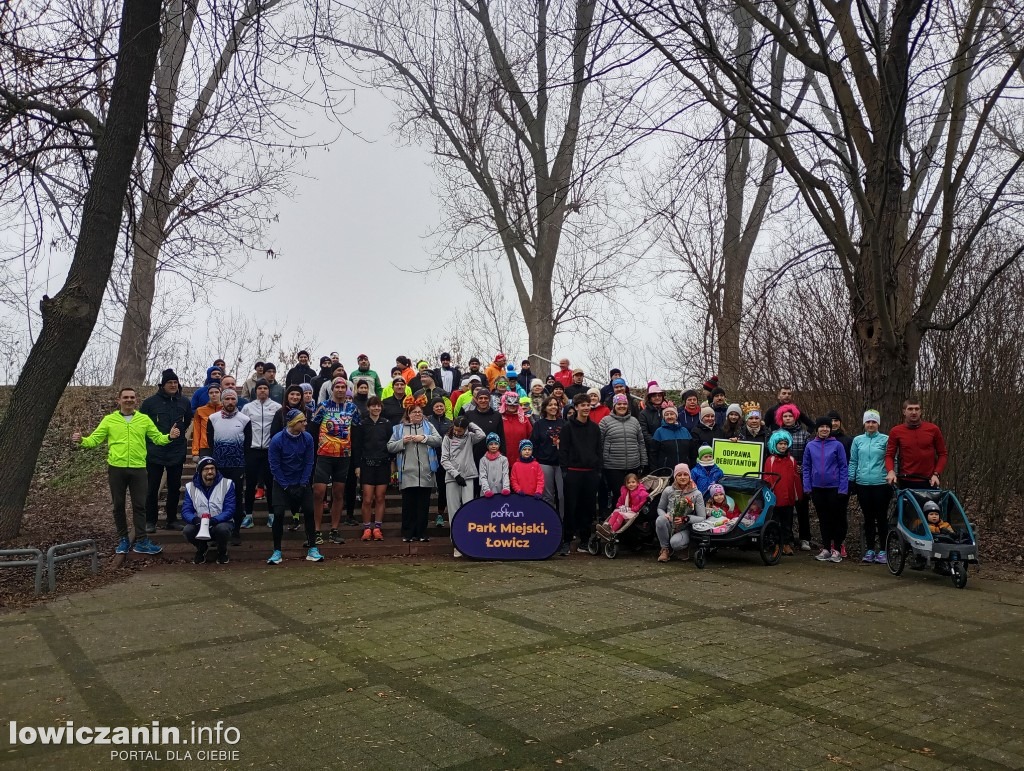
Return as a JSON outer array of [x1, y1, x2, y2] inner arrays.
[[73, 350, 946, 564]]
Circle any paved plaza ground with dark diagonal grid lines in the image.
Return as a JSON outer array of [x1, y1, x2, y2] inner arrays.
[[0, 555, 1024, 770]]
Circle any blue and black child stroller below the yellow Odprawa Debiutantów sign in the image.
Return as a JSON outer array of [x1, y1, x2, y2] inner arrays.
[[690, 471, 782, 569]]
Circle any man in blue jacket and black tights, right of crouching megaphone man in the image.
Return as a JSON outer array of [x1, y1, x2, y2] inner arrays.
[[266, 410, 324, 565]]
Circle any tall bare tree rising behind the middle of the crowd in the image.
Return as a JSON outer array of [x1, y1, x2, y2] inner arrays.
[[304, 0, 632, 365]]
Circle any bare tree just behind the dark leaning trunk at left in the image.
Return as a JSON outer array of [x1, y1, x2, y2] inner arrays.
[[114, 0, 300, 383]]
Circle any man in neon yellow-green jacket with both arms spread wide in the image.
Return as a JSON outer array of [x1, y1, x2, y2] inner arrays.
[[71, 388, 181, 554]]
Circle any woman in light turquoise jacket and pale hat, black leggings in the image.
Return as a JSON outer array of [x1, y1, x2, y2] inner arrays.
[[850, 410, 893, 565]]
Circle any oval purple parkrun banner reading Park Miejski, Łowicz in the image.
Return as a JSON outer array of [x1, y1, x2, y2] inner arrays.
[[452, 495, 562, 559]]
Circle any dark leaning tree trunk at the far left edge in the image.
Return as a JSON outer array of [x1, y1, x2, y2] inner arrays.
[[0, 0, 161, 543]]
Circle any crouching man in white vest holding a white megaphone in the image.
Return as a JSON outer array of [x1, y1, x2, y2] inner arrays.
[[181, 457, 236, 565]]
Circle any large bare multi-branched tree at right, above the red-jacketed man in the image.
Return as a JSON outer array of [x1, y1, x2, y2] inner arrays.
[[612, 0, 1024, 417]]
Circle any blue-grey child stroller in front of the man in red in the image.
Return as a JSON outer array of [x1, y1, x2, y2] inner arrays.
[[886, 487, 978, 589]]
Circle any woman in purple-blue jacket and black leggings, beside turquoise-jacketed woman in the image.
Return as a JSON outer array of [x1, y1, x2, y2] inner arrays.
[[804, 417, 850, 562]]
